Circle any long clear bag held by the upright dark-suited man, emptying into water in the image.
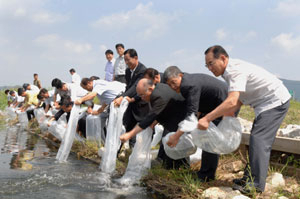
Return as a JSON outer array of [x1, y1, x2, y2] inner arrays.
[[100, 98, 128, 173]]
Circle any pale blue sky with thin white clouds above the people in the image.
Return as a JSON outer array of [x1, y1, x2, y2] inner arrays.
[[0, 0, 300, 88]]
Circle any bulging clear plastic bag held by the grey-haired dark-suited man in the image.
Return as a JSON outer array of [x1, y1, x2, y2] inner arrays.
[[162, 132, 197, 160]]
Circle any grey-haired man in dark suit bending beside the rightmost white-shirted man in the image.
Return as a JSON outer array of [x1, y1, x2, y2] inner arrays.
[[164, 66, 228, 182]]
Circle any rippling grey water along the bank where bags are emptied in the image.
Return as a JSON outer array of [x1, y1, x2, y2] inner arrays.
[[0, 123, 156, 199]]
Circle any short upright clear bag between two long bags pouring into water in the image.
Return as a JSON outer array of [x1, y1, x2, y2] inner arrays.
[[86, 115, 102, 144]]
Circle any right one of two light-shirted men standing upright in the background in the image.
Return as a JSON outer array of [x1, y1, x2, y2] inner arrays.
[[114, 44, 128, 83]]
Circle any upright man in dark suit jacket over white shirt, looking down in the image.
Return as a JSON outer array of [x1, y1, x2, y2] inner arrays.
[[114, 49, 149, 147]]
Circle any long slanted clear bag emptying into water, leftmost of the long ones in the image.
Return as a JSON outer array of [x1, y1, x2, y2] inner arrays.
[[56, 105, 80, 162]]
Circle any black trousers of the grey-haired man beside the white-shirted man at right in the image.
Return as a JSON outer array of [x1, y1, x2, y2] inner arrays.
[[197, 114, 222, 181]]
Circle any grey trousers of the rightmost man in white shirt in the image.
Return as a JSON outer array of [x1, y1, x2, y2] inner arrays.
[[244, 101, 290, 191]]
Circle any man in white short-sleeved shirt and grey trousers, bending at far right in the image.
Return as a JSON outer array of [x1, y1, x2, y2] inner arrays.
[[198, 46, 291, 194]]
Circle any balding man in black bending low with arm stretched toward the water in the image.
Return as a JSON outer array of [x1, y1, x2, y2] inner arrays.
[[120, 78, 185, 168]]
